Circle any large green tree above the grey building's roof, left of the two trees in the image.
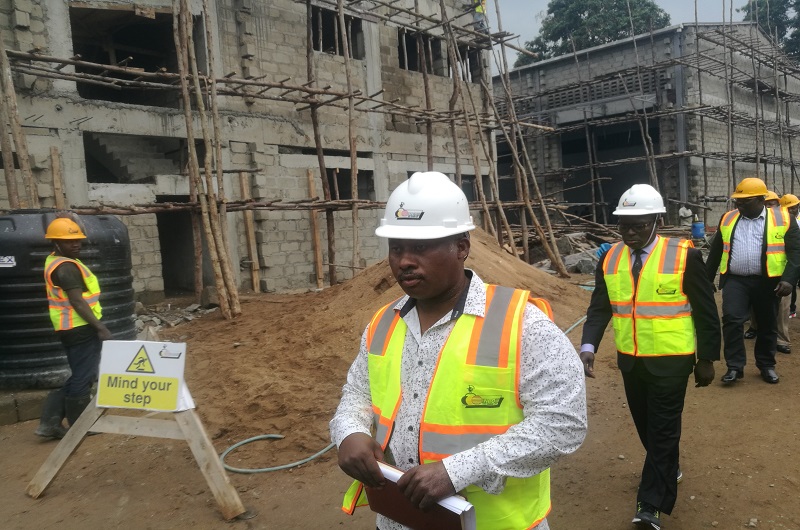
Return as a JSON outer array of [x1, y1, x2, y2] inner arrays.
[[514, 0, 672, 67]]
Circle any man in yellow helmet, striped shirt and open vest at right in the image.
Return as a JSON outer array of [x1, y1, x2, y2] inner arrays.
[[707, 178, 800, 384]]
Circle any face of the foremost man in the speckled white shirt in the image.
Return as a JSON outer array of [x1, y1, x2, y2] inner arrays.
[[389, 235, 470, 301]]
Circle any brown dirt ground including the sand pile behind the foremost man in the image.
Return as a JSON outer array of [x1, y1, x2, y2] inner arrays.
[[0, 228, 800, 530]]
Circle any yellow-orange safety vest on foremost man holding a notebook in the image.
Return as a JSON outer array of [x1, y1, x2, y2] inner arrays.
[[342, 285, 552, 530]]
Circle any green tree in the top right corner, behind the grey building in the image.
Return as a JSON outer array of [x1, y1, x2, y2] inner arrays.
[[736, 0, 800, 58]]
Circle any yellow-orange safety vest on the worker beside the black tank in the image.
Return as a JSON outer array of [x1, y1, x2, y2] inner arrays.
[[44, 254, 103, 331]]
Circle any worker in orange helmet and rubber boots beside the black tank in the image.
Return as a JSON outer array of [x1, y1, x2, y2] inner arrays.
[[36, 217, 111, 438]]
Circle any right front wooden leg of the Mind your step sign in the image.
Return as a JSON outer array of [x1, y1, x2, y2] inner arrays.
[[175, 409, 246, 520]]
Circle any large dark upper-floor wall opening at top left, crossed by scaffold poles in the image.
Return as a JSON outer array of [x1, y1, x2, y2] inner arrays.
[[69, 3, 206, 108]]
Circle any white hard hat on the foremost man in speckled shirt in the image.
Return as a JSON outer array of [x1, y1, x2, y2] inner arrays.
[[375, 171, 475, 239]]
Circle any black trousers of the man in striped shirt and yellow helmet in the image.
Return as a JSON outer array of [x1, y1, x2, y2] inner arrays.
[[722, 274, 780, 370]]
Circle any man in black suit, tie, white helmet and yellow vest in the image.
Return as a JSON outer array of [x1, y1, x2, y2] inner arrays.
[[580, 184, 721, 530]]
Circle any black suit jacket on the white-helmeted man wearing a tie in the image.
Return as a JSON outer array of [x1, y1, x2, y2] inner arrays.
[[581, 240, 722, 376]]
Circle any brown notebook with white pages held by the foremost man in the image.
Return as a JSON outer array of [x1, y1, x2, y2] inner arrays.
[[365, 462, 475, 530]]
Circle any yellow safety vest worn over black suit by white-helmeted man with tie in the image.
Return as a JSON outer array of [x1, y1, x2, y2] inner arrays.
[[603, 236, 695, 357]]
